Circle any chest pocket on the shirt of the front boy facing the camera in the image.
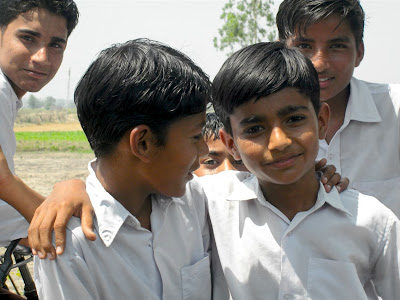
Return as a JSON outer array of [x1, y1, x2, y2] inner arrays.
[[307, 257, 368, 300]]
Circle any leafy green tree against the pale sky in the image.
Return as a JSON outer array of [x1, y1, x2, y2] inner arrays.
[[214, 0, 276, 55]]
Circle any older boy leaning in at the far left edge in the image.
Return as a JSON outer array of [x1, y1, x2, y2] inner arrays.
[[0, 0, 94, 252]]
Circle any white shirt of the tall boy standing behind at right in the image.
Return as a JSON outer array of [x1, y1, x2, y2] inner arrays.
[[318, 78, 400, 217]]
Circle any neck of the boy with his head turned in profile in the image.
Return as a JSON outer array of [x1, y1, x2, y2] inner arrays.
[[95, 155, 152, 230]]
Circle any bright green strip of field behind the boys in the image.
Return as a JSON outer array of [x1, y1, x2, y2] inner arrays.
[[15, 131, 92, 153]]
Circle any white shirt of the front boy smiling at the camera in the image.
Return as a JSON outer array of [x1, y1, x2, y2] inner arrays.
[[201, 171, 400, 300]]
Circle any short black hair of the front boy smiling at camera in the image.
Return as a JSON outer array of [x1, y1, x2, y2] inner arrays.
[[212, 42, 320, 134]]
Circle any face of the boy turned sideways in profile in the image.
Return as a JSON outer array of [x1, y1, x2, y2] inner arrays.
[[151, 112, 208, 197]]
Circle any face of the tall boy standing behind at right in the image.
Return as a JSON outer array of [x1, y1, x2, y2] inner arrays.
[[287, 15, 364, 101]]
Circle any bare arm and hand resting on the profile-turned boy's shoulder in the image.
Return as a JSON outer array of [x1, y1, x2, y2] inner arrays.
[[0, 147, 96, 258]]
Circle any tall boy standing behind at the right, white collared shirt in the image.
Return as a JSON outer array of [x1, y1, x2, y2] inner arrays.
[[276, 0, 400, 217]]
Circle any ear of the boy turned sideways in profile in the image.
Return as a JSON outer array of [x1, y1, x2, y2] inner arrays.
[[129, 125, 154, 162]]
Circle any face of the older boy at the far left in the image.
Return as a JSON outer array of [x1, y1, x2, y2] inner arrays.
[[0, 9, 68, 98]]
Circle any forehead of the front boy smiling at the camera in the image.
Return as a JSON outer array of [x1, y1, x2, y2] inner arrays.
[[230, 88, 314, 128]]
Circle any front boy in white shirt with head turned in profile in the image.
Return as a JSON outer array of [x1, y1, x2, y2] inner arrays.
[[35, 39, 211, 300]]
